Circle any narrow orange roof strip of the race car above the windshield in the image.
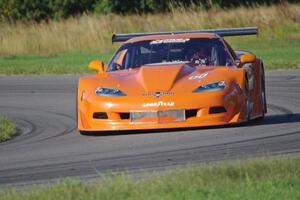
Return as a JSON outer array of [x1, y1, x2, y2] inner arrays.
[[124, 33, 220, 44]]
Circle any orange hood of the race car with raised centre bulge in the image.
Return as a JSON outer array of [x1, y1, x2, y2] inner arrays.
[[93, 64, 229, 95]]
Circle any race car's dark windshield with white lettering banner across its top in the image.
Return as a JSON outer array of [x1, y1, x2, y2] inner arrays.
[[107, 38, 232, 71]]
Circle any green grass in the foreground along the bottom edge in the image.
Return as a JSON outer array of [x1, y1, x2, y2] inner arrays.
[[0, 158, 300, 200]]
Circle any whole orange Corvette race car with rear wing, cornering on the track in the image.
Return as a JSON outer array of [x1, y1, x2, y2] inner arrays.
[[77, 28, 267, 132]]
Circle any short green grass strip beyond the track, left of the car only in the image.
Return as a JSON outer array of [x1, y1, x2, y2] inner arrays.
[[0, 52, 112, 75]]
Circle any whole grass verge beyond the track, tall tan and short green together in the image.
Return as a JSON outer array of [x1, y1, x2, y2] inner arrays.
[[0, 4, 300, 75]]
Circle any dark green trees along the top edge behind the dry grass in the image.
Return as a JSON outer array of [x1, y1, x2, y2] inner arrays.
[[0, 0, 300, 21]]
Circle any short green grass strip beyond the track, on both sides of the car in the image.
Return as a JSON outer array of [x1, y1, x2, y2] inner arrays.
[[0, 36, 300, 75]]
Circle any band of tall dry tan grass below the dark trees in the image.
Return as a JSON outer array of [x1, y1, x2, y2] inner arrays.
[[0, 3, 300, 56]]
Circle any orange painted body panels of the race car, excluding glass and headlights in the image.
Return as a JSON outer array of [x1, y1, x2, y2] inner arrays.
[[77, 34, 263, 131]]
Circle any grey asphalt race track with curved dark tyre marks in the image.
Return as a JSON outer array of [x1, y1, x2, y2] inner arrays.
[[0, 71, 300, 187]]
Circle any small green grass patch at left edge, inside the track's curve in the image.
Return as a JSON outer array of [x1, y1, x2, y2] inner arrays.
[[0, 116, 16, 142]]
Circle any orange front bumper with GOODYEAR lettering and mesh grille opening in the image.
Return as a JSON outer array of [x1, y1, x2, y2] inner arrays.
[[78, 88, 244, 131]]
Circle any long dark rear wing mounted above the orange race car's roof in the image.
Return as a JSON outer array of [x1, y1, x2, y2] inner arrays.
[[112, 27, 258, 42]]
